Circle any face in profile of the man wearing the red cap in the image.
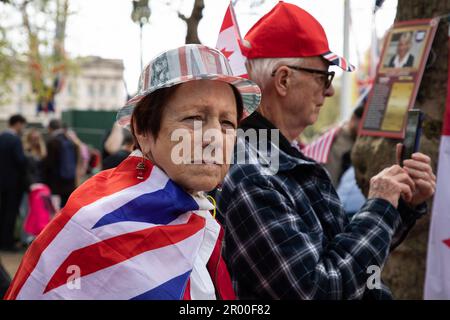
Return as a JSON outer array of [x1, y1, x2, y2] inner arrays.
[[286, 57, 334, 128]]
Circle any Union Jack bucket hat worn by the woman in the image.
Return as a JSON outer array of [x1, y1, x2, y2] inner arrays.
[[117, 44, 261, 126]]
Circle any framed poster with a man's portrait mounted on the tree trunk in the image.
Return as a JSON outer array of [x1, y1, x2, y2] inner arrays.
[[359, 19, 439, 139]]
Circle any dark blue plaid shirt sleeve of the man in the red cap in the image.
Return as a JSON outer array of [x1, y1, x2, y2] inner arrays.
[[222, 179, 400, 299]]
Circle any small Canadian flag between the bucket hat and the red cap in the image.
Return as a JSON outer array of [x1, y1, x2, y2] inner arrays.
[[216, 1, 248, 78]]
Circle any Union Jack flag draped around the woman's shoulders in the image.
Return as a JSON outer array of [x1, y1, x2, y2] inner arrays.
[[5, 152, 224, 299]]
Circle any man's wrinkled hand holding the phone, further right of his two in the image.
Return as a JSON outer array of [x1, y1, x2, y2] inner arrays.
[[397, 143, 436, 207]]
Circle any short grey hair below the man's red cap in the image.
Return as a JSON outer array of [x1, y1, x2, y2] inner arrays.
[[247, 58, 304, 90]]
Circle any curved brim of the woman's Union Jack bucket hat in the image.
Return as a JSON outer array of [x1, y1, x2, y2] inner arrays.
[[116, 74, 261, 127]]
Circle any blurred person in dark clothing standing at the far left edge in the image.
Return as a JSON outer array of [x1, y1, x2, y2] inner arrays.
[[0, 114, 29, 251]]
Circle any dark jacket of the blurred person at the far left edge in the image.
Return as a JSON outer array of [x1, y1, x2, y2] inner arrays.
[[0, 130, 27, 190]]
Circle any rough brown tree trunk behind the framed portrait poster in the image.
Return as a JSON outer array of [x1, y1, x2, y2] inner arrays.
[[352, 0, 450, 299]]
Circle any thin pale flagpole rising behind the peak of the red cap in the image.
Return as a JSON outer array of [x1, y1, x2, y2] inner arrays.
[[340, 0, 351, 122]]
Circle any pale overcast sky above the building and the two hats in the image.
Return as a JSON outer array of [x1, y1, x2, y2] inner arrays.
[[3, 0, 397, 93]]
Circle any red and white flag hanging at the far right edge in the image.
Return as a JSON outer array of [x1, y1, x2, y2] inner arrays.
[[424, 26, 450, 300]]
